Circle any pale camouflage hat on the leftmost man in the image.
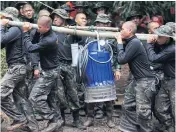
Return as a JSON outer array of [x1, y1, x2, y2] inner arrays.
[[0, 7, 19, 21]]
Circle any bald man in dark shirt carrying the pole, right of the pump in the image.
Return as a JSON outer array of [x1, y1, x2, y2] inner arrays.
[[116, 21, 156, 132]]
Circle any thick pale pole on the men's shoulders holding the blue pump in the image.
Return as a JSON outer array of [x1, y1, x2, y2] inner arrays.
[[9, 21, 175, 40]]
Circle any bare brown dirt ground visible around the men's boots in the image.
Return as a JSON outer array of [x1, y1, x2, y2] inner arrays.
[[1, 65, 129, 132]]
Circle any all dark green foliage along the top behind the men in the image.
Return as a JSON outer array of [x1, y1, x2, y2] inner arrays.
[[1, 1, 175, 21]]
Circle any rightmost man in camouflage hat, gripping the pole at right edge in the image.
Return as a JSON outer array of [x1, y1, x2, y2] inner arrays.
[[146, 25, 175, 132]]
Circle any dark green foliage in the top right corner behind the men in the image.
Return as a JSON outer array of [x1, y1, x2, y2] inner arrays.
[[113, 1, 175, 21]]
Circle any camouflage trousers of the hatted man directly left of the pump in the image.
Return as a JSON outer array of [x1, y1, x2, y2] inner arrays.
[[58, 63, 80, 111]]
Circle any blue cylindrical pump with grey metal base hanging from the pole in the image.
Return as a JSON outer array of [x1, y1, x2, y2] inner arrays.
[[85, 41, 116, 103]]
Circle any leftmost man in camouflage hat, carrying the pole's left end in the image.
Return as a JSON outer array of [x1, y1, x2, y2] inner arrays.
[[0, 7, 38, 132]]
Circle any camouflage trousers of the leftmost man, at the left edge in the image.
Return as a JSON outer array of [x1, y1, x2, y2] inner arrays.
[[1, 64, 38, 131]]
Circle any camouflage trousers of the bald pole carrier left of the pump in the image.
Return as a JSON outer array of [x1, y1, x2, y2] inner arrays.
[[29, 67, 61, 121]]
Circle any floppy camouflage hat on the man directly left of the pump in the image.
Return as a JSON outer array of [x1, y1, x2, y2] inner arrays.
[[50, 9, 70, 19]]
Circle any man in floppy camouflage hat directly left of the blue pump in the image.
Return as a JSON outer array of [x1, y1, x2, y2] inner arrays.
[[51, 9, 84, 129]]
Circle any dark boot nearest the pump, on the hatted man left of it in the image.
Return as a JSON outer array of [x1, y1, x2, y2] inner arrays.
[[72, 110, 86, 130]]
